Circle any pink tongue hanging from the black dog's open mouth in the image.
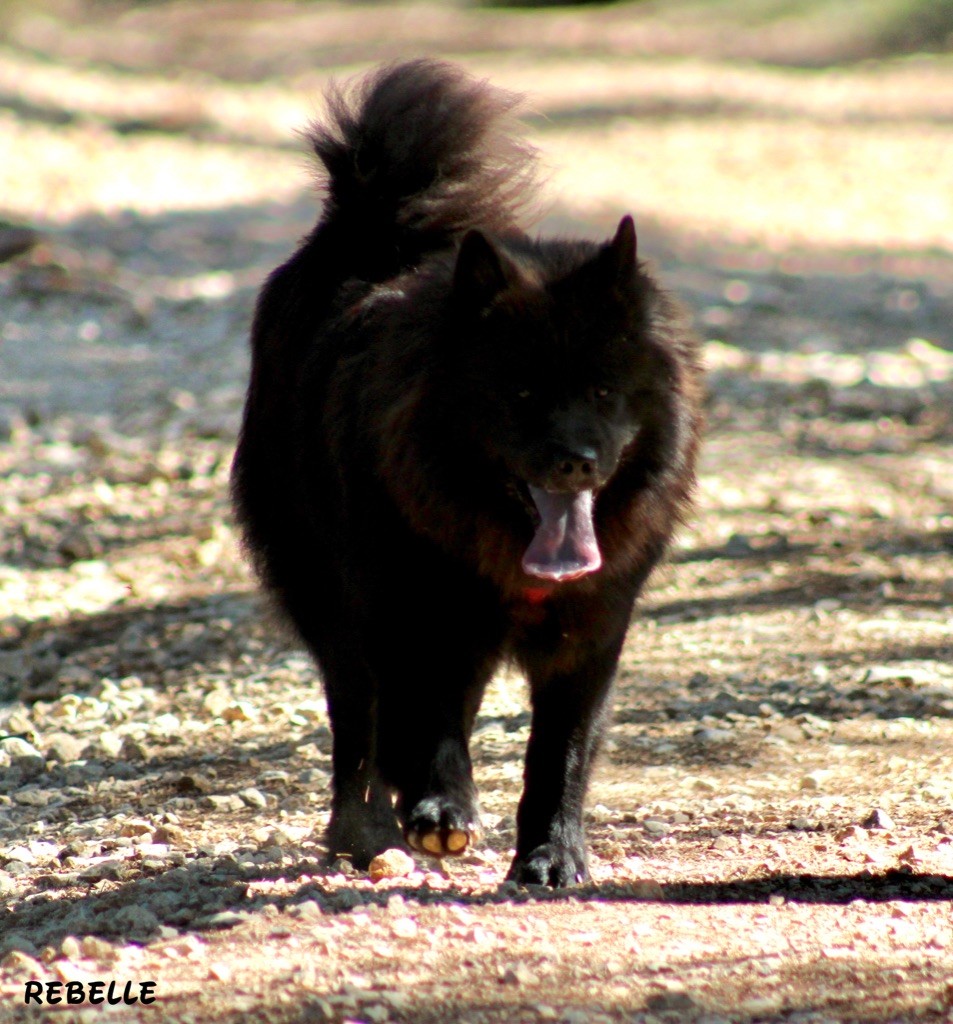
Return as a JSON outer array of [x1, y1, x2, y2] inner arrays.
[[523, 486, 602, 583]]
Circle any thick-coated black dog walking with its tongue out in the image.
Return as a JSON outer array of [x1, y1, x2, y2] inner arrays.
[[233, 60, 701, 886]]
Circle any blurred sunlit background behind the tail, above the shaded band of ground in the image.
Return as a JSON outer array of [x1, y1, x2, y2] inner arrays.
[[0, 0, 953, 241]]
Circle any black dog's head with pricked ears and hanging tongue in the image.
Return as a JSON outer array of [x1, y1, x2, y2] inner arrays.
[[451, 217, 664, 581]]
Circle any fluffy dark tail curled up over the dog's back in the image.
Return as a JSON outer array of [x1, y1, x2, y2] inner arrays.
[[308, 59, 535, 280]]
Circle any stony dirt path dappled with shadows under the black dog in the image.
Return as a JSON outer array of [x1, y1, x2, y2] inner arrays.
[[0, 5, 953, 1024]]
